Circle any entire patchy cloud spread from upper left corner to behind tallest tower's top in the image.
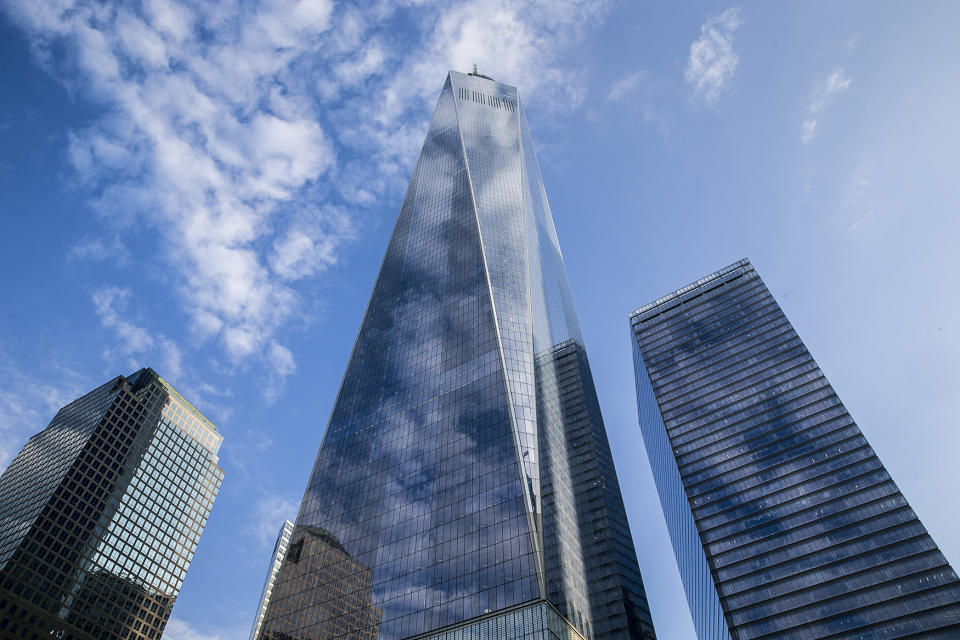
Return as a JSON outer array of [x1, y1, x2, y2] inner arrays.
[[5, 0, 606, 400]]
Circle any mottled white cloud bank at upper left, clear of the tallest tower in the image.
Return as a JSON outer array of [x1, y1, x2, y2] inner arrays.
[[10, 0, 338, 375]]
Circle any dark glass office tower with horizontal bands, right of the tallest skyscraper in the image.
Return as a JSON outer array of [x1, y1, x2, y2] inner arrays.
[[630, 260, 960, 640]]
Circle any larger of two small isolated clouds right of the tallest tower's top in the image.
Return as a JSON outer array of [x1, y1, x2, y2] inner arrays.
[[683, 7, 743, 103]]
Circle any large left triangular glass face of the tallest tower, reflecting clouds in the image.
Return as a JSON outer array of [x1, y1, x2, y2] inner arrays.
[[262, 78, 541, 640]]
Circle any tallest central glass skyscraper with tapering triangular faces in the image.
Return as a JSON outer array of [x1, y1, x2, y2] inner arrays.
[[261, 72, 654, 640]]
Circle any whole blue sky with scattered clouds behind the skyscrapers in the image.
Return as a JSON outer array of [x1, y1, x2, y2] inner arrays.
[[0, 0, 960, 640]]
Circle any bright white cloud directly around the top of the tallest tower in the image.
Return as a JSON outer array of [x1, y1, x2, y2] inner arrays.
[[339, 0, 607, 175]]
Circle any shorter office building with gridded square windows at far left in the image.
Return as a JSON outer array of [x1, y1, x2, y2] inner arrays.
[[0, 369, 223, 640]]
